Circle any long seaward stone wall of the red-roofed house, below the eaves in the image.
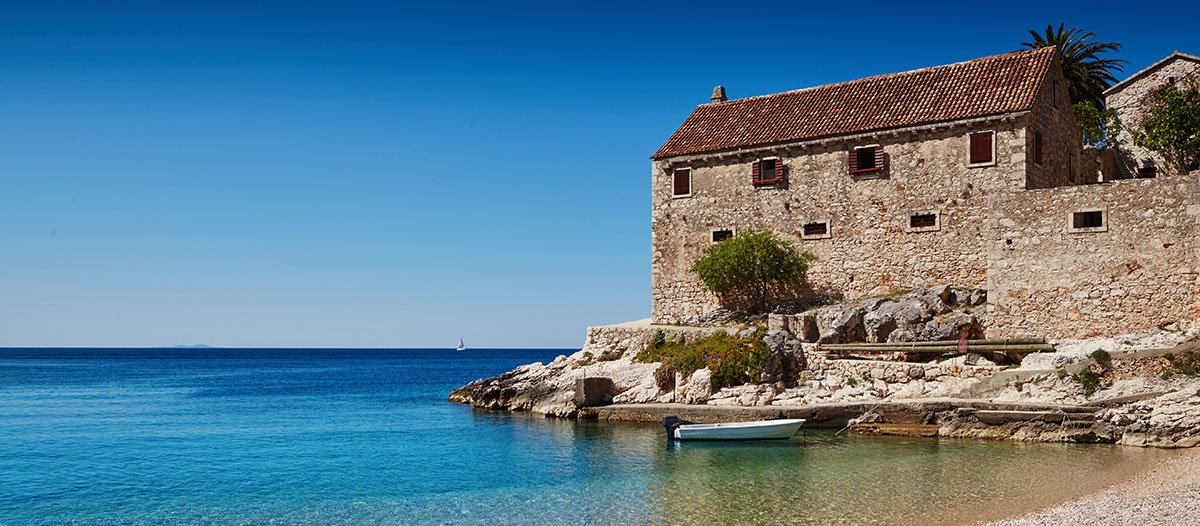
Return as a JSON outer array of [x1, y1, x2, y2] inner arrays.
[[652, 119, 1027, 323]]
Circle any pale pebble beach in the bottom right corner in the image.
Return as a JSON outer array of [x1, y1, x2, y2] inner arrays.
[[988, 450, 1200, 526]]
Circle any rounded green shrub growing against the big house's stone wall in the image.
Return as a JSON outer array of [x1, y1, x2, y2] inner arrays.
[[691, 232, 816, 312]]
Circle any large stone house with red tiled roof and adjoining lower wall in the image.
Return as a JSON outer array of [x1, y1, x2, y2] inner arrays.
[[652, 48, 1200, 336]]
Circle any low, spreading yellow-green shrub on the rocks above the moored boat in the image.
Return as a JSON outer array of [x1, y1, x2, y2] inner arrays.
[[635, 331, 770, 389]]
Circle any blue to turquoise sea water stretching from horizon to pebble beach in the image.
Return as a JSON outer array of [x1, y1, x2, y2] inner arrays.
[[0, 349, 1163, 525]]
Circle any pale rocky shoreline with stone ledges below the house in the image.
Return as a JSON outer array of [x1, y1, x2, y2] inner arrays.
[[449, 287, 1200, 448]]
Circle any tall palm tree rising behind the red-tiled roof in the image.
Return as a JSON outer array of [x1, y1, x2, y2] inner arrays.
[[1021, 24, 1128, 108]]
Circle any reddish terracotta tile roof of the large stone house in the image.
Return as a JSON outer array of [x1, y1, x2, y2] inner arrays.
[[653, 48, 1054, 159]]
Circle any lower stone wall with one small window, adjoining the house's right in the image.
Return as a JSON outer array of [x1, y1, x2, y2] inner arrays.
[[986, 173, 1200, 337]]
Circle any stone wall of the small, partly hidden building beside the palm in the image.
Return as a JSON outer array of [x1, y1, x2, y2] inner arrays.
[[1105, 58, 1200, 178]]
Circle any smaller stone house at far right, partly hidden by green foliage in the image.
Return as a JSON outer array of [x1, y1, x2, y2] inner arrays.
[[1104, 52, 1200, 178]]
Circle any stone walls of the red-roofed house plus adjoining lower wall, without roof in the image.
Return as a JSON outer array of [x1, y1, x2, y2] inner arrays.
[[652, 47, 1200, 337]]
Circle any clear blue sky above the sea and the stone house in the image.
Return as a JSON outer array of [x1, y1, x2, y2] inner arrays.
[[0, 1, 1200, 347]]
